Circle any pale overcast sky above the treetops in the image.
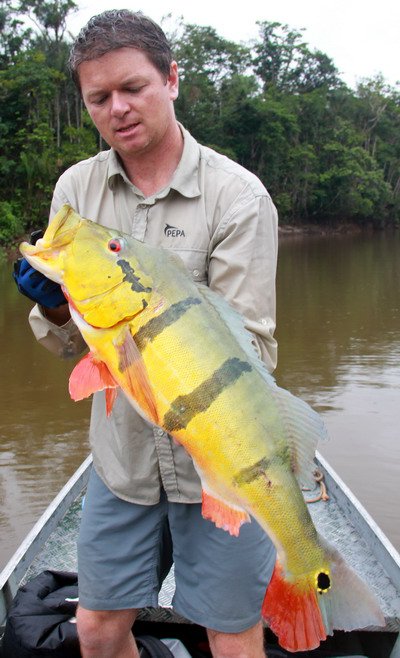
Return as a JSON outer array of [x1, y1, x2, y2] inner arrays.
[[68, 0, 400, 88]]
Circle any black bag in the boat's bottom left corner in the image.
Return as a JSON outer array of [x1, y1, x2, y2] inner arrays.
[[2, 571, 81, 658]]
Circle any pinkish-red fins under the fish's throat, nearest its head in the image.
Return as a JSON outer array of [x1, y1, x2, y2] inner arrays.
[[69, 352, 118, 415]]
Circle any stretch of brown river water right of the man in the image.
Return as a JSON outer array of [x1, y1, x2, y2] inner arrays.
[[277, 232, 400, 549]]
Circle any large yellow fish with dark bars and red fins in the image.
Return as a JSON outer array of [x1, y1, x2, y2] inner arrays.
[[21, 206, 384, 651]]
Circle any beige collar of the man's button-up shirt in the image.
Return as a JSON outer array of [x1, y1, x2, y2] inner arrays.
[[108, 124, 200, 198]]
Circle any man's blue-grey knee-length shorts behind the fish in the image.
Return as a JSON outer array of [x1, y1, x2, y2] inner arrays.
[[78, 469, 275, 633]]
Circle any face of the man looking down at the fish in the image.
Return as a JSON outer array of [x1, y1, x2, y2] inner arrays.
[[78, 48, 178, 159]]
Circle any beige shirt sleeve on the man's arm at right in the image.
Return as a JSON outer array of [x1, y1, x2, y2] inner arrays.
[[209, 190, 278, 372]]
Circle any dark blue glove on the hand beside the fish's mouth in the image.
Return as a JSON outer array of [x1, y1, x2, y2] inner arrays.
[[13, 231, 67, 308]]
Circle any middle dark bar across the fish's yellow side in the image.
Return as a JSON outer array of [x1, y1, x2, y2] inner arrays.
[[163, 357, 252, 432]]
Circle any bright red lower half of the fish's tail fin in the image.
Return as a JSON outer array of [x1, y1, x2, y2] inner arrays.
[[262, 561, 327, 651]]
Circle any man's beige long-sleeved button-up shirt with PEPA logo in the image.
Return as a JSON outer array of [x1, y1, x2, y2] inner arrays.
[[30, 127, 278, 504]]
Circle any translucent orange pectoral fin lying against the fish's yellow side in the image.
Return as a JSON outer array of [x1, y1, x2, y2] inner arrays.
[[116, 328, 158, 425]]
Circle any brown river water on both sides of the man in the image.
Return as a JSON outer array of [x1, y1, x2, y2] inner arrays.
[[0, 231, 400, 568]]
